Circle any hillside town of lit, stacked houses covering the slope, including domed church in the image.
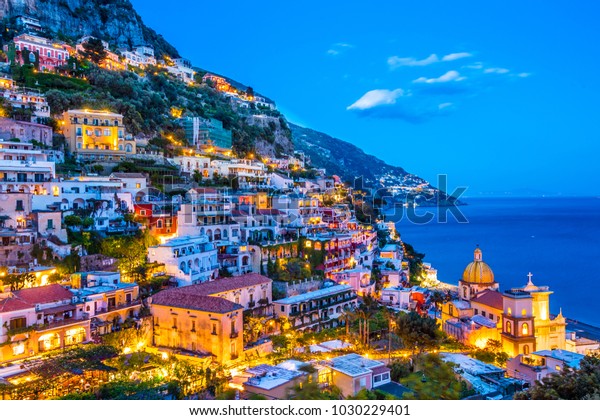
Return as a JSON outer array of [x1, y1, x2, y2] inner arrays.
[[0, 16, 600, 399]]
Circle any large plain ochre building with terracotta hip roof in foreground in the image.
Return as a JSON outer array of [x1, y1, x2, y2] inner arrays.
[[151, 285, 244, 363]]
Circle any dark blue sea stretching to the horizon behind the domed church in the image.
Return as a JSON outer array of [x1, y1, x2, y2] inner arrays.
[[388, 197, 600, 326]]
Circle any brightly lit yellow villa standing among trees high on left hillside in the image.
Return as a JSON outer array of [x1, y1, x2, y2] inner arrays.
[[63, 109, 136, 161]]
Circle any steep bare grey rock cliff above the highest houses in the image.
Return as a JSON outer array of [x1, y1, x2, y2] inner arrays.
[[0, 0, 179, 57]]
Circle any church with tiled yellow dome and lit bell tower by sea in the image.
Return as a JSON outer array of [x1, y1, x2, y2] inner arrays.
[[442, 248, 566, 357]]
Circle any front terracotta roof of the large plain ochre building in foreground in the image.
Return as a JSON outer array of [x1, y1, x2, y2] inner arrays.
[[152, 287, 244, 314]]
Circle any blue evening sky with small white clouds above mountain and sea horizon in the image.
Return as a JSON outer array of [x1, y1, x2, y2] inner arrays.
[[132, 0, 600, 195]]
